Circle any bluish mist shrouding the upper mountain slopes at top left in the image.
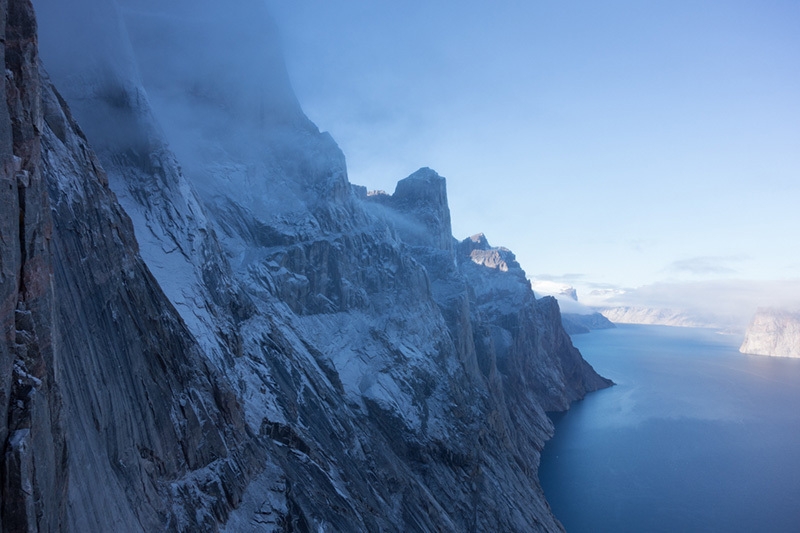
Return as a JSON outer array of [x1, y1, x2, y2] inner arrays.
[[36, 0, 347, 224]]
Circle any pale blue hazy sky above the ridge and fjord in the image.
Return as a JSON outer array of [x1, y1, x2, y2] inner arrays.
[[266, 0, 800, 316]]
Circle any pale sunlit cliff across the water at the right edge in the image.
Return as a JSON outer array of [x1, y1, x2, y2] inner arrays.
[[739, 308, 800, 357]]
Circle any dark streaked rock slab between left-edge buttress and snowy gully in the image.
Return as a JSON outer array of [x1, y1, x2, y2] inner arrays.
[[42, 77, 262, 531]]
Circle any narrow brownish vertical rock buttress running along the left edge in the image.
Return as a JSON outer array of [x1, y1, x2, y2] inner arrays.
[[0, 0, 66, 531]]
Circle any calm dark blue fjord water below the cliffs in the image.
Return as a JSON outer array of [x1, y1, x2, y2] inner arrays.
[[539, 326, 800, 533]]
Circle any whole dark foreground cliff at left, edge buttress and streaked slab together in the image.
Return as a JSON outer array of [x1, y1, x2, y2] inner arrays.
[[0, 1, 260, 531]]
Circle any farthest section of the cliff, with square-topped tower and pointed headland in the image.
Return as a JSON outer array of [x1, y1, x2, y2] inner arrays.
[[364, 178, 611, 516]]
